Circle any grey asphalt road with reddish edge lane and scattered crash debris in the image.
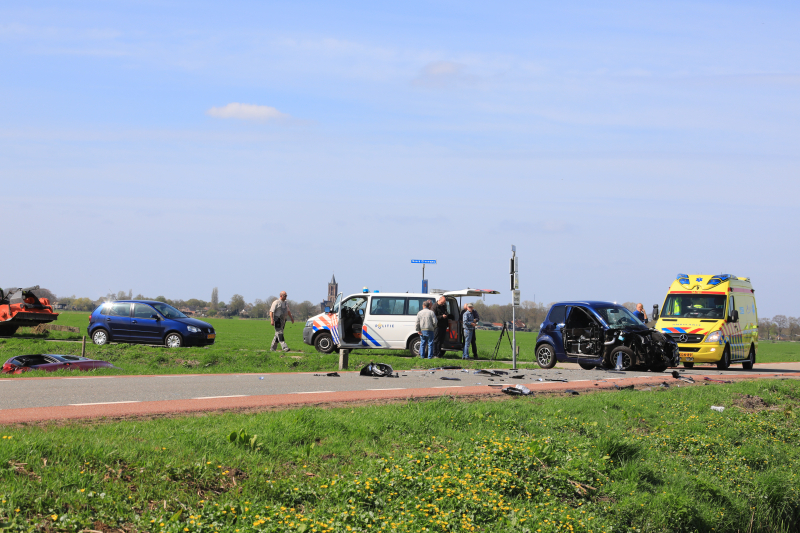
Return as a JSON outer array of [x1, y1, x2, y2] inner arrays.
[[0, 363, 800, 423]]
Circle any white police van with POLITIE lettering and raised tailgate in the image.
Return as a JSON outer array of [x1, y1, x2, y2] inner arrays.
[[303, 289, 500, 356]]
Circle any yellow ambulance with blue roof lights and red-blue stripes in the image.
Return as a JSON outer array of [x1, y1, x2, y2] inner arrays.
[[652, 274, 758, 370]]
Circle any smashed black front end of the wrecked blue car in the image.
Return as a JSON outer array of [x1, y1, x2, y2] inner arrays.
[[603, 328, 680, 372]]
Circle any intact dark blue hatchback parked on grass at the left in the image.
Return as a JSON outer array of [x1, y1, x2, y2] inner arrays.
[[87, 300, 217, 348]]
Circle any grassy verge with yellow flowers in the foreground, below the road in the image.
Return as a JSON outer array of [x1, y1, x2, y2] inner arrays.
[[0, 381, 800, 533]]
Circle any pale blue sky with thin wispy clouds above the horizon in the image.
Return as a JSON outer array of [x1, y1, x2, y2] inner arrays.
[[0, 1, 800, 316]]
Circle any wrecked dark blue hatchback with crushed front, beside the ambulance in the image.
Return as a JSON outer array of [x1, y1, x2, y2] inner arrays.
[[536, 301, 679, 372]]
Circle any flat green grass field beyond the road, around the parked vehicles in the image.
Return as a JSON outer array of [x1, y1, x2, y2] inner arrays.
[[0, 312, 800, 376]]
